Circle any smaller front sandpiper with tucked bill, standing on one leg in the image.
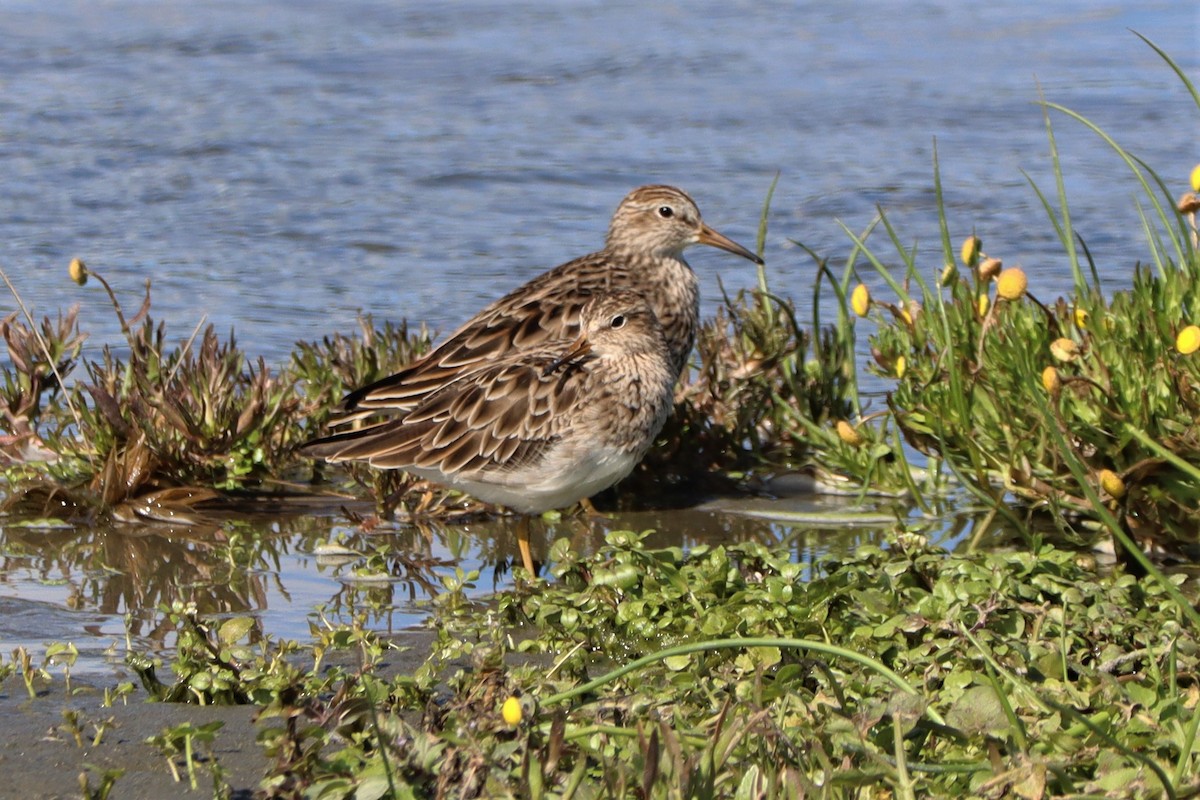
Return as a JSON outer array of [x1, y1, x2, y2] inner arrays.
[[304, 290, 677, 575]]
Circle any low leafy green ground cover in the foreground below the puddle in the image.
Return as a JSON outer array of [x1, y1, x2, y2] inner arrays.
[[30, 531, 1200, 798]]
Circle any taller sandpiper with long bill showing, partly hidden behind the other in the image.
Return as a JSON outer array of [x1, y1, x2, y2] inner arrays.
[[335, 186, 762, 425]]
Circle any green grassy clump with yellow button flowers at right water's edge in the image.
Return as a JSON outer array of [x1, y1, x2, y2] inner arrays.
[[863, 107, 1200, 546]]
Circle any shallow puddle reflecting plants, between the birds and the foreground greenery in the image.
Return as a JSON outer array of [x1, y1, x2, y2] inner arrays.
[[0, 494, 916, 669]]
